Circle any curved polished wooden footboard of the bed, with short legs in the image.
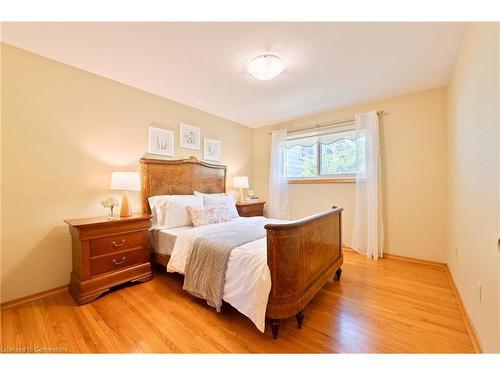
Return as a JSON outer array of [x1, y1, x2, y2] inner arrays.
[[265, 207, 343, 338]]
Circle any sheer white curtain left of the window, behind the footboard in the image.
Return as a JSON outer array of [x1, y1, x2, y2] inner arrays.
[[267, 130, 289, 219]]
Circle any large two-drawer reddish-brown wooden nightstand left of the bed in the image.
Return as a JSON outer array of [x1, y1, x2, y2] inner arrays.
[[64, 214, 152, 305]]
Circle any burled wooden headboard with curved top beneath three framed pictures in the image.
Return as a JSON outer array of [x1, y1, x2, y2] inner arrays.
[[141, 156, 227, 213]]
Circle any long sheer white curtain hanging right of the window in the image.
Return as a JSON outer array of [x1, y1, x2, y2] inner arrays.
[[351, 111, 384, 259]]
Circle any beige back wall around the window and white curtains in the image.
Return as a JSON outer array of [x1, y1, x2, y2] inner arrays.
[[253, 88, 446, 262]]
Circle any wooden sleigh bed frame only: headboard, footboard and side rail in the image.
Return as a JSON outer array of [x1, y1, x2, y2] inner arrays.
[[141, 157, 343, 338]]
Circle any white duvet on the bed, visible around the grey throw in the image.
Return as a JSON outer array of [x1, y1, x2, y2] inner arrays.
[[167, 216, 283, 332]]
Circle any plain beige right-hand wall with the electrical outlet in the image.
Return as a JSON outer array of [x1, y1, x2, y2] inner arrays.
[[447, 23, 500, 352]]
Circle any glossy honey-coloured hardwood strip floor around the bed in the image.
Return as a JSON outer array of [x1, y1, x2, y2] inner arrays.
[[2, 251, 474, 353]]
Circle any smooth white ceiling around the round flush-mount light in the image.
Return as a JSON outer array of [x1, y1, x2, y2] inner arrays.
[[2, 22, 465, 127]]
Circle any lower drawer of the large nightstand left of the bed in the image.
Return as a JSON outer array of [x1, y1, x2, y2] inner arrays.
[[90, 248, 149, 276]]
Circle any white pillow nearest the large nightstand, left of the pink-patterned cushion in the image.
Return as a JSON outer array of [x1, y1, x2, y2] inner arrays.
[[150, 195, 203, 228]]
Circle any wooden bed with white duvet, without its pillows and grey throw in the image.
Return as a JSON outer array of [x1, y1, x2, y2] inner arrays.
[[141, 157, 343, 339]]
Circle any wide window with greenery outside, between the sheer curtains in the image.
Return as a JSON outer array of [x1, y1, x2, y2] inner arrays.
[[286, 125, 365, 180]]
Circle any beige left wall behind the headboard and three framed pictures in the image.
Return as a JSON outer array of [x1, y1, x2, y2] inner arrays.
[[1, 45, 253, 301]]
